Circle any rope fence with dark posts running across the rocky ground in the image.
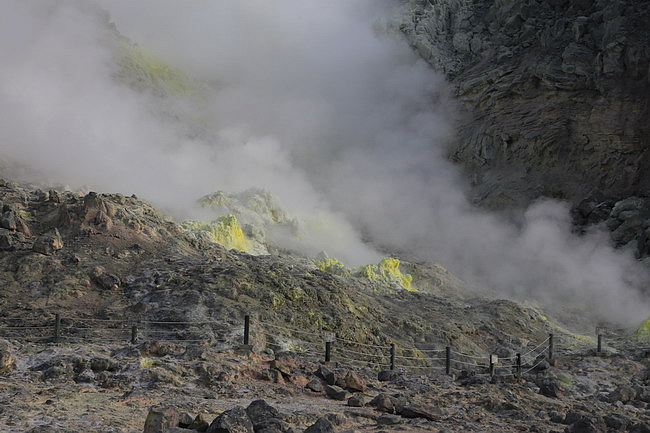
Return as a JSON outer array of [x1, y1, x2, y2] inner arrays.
[[5, 314, 650, 378]]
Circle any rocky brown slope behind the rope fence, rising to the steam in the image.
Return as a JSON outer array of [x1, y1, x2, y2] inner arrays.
[[0, 177, 576, 361]]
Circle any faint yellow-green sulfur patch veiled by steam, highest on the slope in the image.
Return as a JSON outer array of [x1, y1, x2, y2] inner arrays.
[[120, 45, 192, 95]]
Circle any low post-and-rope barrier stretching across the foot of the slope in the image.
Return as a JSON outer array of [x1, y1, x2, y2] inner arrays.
[[8, 313, 650, 377]]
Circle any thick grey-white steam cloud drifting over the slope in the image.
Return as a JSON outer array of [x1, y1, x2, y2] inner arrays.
[[0, 0, 650, 323]]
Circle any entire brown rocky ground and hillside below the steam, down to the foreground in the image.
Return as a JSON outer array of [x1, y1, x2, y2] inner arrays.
[[0, 170, 650, 433]]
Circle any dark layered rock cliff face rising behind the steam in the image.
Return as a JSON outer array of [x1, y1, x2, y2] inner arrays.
[[400, 0, 650, 208]]
